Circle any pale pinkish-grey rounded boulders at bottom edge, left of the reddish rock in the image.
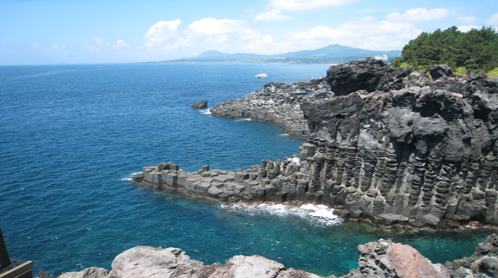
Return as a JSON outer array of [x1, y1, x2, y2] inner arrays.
[[58, 246, 321, 278]]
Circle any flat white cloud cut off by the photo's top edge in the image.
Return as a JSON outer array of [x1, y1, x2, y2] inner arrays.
[[269, 0, 358, 11]]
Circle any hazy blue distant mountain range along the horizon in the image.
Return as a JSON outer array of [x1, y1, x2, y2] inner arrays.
[[158, 44, 401, 64]]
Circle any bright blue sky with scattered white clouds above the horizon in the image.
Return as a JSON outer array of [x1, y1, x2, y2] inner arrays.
[[0, 0, 498, 65]]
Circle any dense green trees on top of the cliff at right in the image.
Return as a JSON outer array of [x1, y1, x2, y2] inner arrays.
[[392, 26, 498, 75]]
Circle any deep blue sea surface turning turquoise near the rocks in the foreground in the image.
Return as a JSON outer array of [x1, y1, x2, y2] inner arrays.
[[0, 64, 489, 276]]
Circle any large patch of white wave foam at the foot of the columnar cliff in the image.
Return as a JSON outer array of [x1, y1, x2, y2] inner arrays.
[[220, 203, 342, 226]]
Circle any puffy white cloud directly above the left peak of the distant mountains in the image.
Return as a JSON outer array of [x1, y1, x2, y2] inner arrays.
[[188, 18, 245, 36]]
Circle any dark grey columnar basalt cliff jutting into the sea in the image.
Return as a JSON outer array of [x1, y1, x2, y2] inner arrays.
[[133, 58, 498, 227]]
